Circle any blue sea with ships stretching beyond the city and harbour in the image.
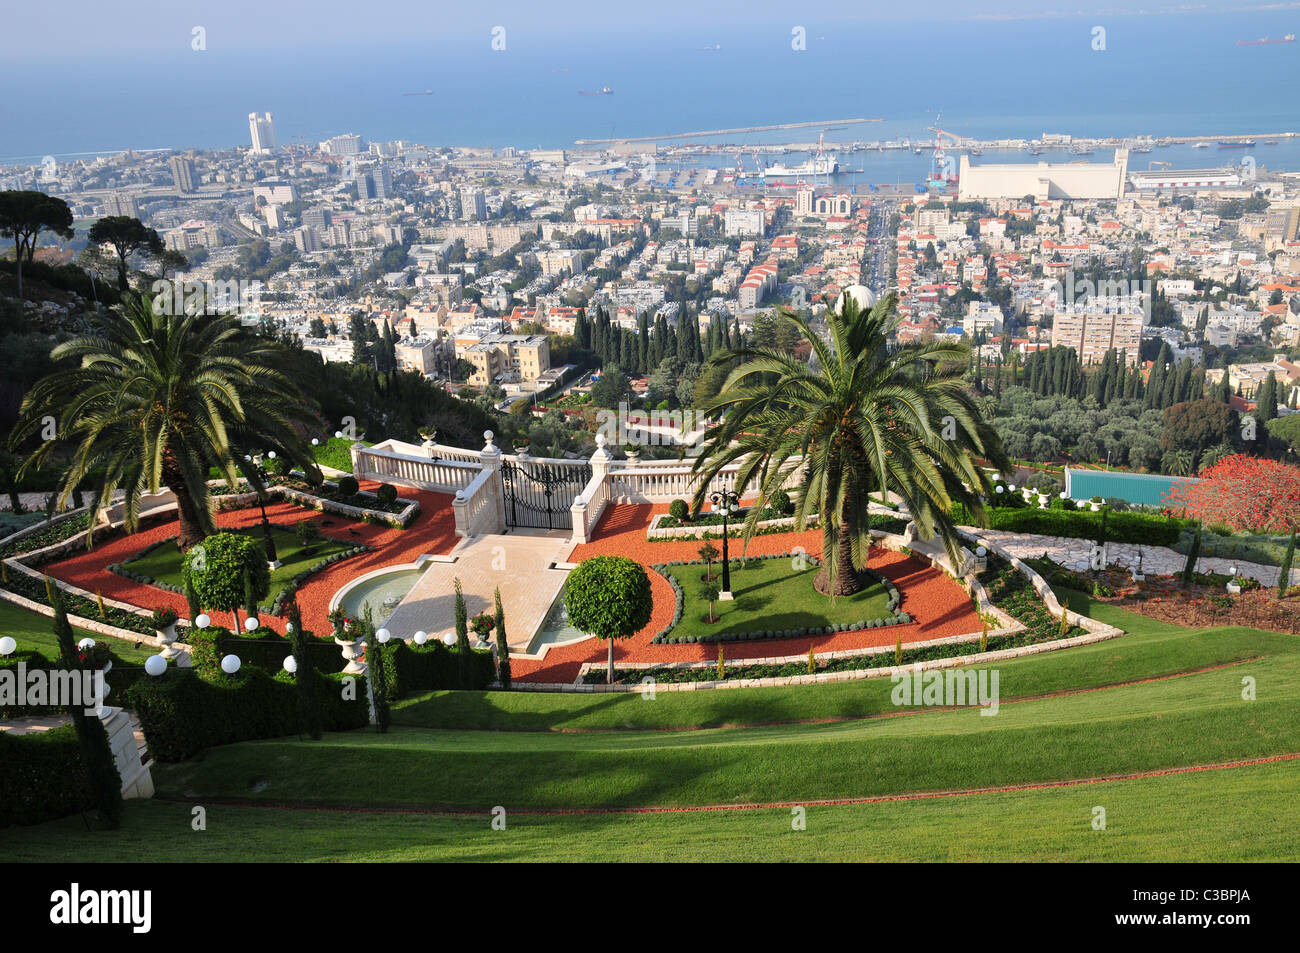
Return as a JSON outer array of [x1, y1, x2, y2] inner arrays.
[[0, 7, 1300, 183]]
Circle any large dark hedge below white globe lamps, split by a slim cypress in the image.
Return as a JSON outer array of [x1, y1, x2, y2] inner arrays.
[[126, 666, 371, 762]]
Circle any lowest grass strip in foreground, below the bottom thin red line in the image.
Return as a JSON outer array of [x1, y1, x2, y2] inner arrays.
[[0, 762, 1300, 863]]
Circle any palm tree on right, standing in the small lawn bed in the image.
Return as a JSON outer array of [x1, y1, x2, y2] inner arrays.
[[694, 295, 1008, 597]]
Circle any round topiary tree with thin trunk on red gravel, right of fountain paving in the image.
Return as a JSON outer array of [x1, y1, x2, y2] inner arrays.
[[564, 556, 654, 683]]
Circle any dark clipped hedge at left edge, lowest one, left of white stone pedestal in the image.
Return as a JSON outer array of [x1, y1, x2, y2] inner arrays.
[[0, 724, 95, 829]]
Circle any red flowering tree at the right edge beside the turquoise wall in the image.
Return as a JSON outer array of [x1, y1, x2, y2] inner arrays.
[[1165, 454, 1300, 533]]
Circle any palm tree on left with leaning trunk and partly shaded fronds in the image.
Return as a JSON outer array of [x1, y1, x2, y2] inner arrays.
[[10, 294, 319, 551]]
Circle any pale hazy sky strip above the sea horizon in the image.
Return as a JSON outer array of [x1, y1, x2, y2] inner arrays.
[[0, 0, 1300, 65]]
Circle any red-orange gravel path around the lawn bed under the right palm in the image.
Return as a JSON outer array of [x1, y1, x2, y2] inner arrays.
[[511, 503, 982, 683]]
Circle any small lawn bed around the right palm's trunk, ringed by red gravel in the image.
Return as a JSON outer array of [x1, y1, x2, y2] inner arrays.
[[664, 559, 889, 638]]
